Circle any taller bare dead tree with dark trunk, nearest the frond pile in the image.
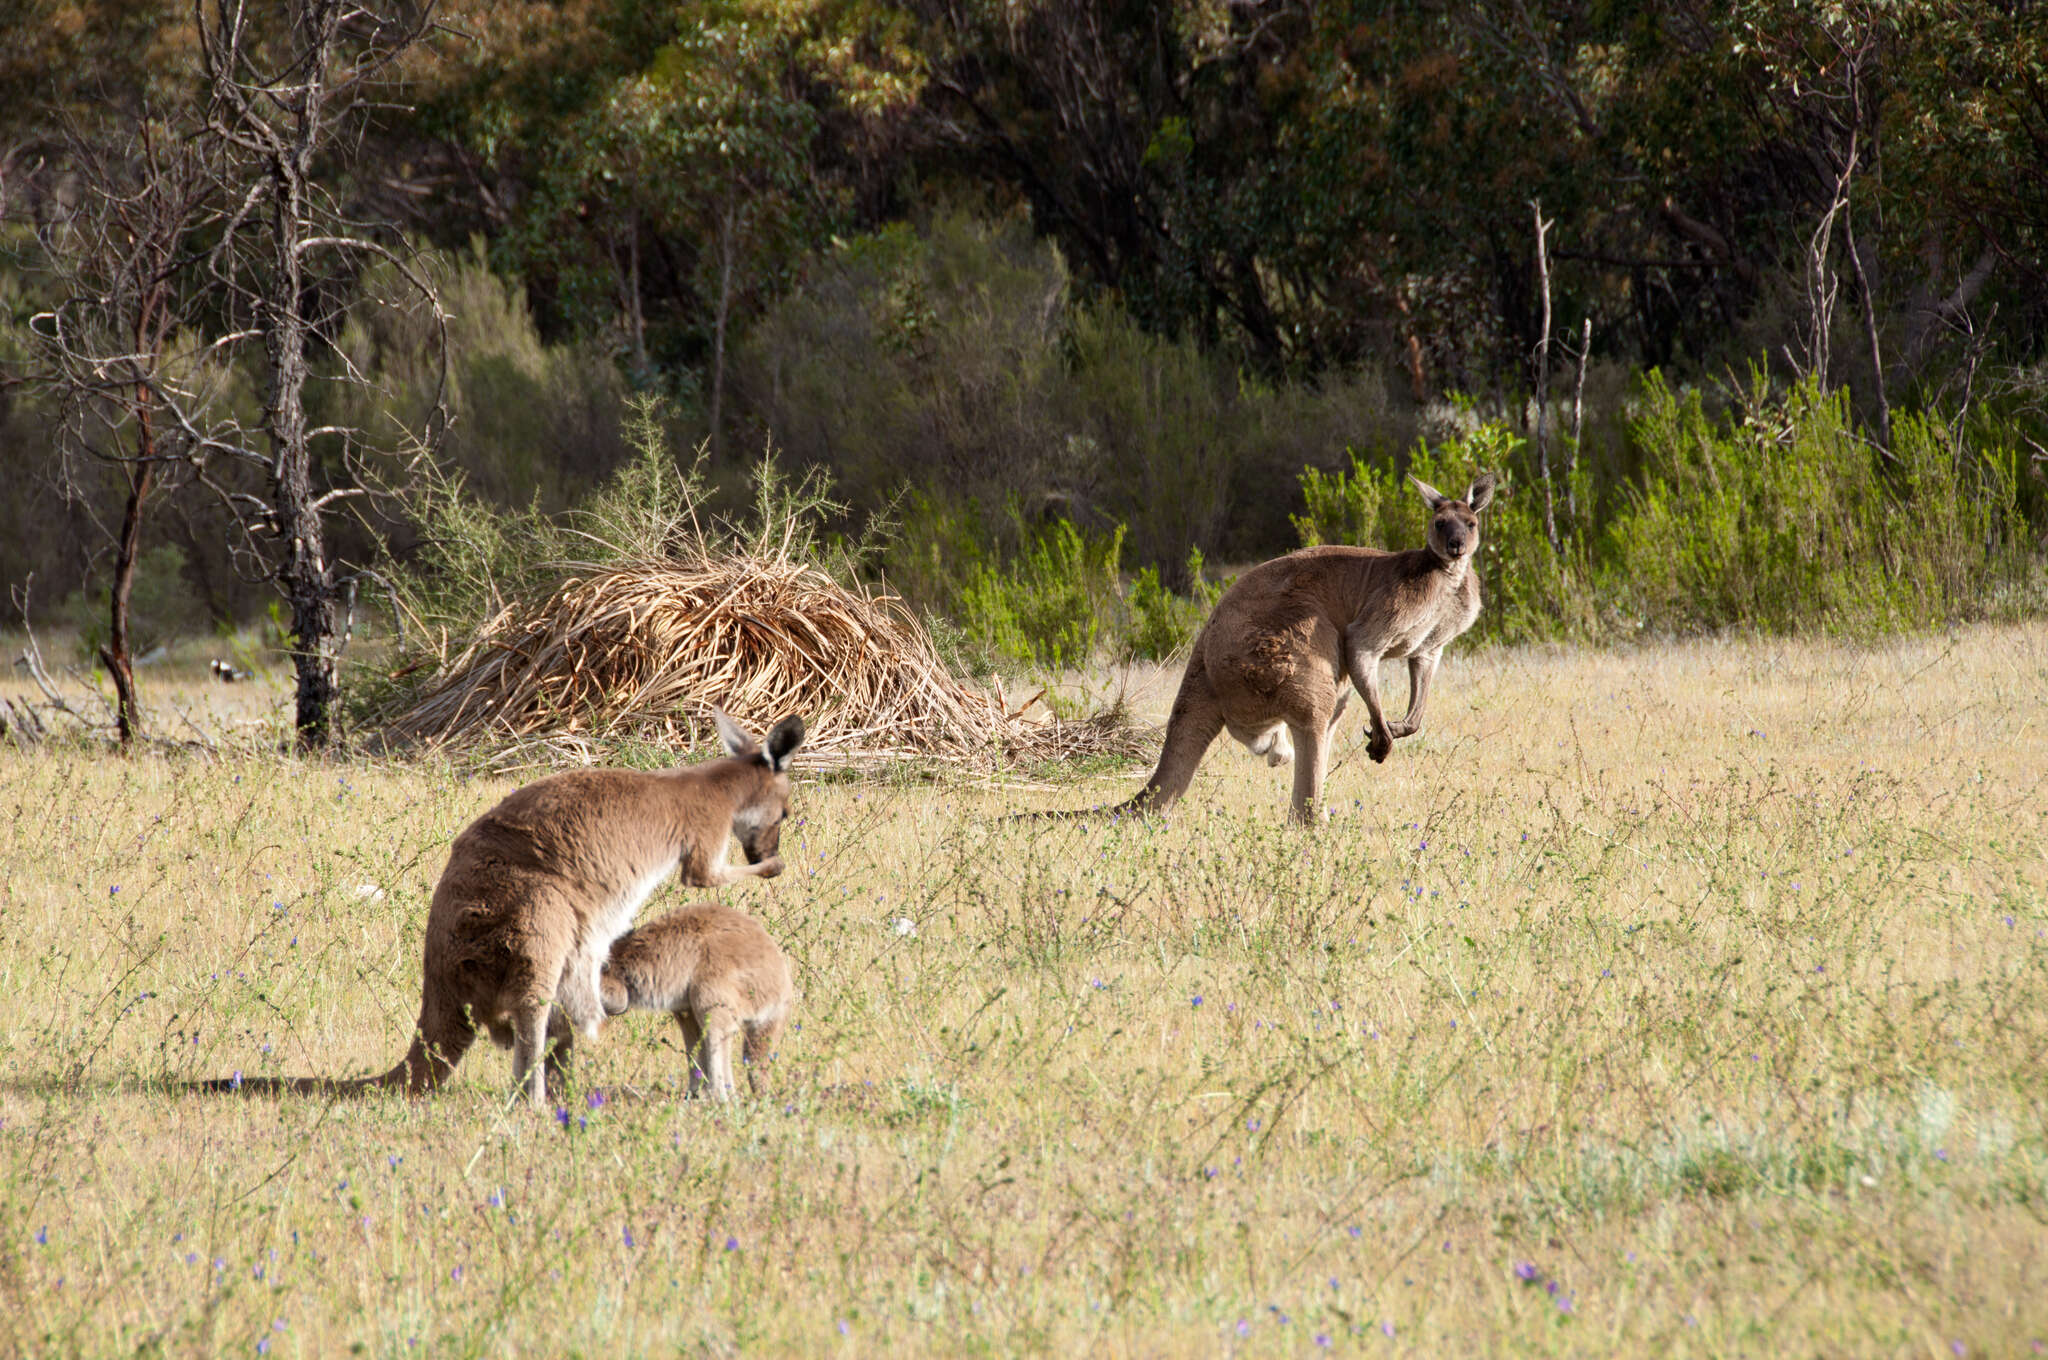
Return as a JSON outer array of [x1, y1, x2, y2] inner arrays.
[[180, 0, 444, 746]]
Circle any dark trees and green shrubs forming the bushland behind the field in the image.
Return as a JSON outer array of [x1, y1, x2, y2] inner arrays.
[[0, 0, 2048, 680]]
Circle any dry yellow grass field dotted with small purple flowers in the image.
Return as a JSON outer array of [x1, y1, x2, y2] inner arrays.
[[0, 625, 2048, 1356]]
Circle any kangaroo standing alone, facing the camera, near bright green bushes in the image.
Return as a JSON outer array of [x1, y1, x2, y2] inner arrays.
[[1064, 475, 1493, 821]]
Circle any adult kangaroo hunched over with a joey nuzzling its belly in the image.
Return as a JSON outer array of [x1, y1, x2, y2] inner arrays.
[[203, 709, 803, 1108]]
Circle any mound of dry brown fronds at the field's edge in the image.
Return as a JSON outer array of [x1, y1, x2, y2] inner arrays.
[[387, 551, 1135, 768]]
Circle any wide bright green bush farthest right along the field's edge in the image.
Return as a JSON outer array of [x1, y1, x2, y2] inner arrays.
[[1602, 375, 2032, 631]]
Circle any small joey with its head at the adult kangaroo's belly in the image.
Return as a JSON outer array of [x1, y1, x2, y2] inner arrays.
[[600, 901, 795, 1100]]
